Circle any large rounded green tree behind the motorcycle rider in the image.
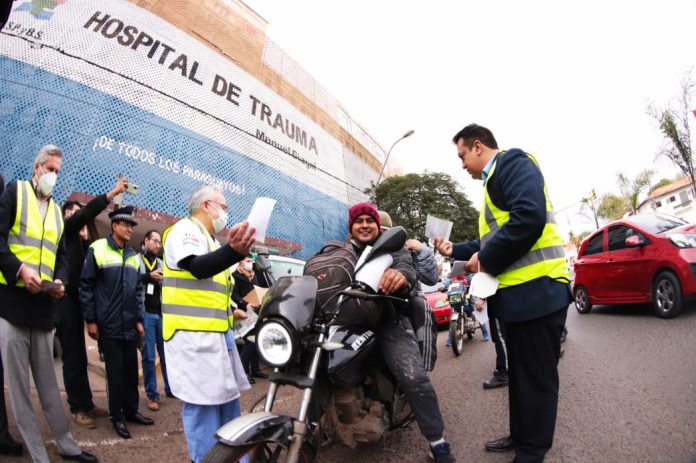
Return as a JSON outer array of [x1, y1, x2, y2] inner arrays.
[[374, 172, 479, 243]]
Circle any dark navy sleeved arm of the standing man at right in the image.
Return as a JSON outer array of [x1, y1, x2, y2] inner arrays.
[[479, 149, 546, 275]]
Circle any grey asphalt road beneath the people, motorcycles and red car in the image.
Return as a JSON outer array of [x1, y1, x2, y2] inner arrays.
[[2, 304, 696, 463]]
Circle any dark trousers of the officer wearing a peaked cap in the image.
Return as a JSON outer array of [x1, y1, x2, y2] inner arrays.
[[102, 338, 138, 421]]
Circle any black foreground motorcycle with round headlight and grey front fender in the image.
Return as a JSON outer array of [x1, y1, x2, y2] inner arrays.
[[204, 227, 414, 463]]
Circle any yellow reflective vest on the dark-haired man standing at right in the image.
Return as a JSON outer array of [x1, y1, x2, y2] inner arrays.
[[479, 151, 570, 288]]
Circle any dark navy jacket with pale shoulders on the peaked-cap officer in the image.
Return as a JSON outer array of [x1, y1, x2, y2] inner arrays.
[[80, 235, 144, 340]]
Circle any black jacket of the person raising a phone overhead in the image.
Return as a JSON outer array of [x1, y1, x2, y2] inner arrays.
[[56, 195, 109, 300]]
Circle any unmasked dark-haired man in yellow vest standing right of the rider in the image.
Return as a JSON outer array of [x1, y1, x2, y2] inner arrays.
[[435, 124, 571, 463]]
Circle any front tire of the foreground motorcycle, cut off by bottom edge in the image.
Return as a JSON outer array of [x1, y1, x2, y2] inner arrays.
[[203, 442, 317, 463]]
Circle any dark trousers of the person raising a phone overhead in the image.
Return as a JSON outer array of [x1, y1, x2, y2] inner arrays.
[[56, 294, 94, 413]]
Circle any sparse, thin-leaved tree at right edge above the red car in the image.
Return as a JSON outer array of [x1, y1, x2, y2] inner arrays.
[[648, 74, 696, 195]]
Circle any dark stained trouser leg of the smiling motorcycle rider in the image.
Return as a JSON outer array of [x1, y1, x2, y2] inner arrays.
[[378, 315, 445, 442]]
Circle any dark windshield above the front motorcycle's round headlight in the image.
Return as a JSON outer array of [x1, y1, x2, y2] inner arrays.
[[259, 276, 317, 331]]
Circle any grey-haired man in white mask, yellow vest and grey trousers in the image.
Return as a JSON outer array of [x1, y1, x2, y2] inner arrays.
[[0, 145, 97, 462]]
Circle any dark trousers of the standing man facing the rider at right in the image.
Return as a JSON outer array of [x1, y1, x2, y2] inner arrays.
[[505, 308, 568, 463]]
